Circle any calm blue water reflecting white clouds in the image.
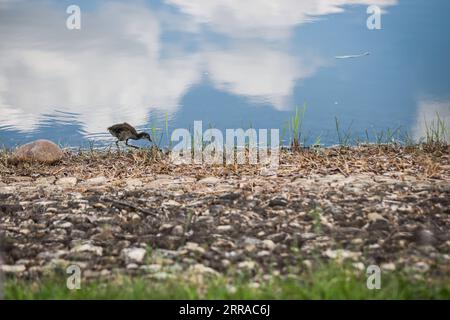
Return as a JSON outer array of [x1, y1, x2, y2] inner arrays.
[[0, 0, 450, 147]]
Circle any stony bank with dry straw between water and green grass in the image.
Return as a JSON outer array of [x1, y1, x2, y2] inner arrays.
[[0, 146, 450, 279]]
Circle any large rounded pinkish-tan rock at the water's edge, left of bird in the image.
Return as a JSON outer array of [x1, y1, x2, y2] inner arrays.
[[11, 140, 64, 164]]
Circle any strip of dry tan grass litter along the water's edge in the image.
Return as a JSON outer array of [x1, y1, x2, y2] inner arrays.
[[0, 144, 450, 180]]
